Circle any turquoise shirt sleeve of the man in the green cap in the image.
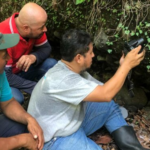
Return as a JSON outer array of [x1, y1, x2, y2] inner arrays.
[[0, 72, 13, 102]]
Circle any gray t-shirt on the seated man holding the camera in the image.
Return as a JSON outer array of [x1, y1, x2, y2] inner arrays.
[[28, 61, 102, 142]]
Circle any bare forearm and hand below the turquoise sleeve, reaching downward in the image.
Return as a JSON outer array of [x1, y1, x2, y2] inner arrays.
[[0, 98, 44, 148]]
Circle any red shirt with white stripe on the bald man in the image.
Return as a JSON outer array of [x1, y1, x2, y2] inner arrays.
[[0, 13, 47, 73]]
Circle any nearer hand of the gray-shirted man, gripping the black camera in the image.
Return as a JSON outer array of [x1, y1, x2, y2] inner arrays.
[[122, 45, 145, 69]]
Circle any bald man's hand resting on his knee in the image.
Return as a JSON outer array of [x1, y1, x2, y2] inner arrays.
[[16, 54, 36, 72]]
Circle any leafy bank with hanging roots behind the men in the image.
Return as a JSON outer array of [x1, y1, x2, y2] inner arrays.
[[0, 0, 150, 70]]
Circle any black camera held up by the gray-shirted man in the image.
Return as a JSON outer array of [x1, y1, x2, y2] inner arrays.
[[124, 38, 144, 55]]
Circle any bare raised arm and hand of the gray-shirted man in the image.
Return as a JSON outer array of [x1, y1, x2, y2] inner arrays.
[[84, 46, 145, 102]]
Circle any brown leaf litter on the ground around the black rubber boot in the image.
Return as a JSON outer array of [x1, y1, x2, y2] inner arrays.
[[89, 108, 150, 150]]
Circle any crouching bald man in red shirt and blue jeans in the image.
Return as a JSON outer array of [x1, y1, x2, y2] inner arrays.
[[0, 2, 57, 103]]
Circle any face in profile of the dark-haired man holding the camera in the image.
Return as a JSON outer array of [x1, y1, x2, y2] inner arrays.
[[82, 43, 94, 71]]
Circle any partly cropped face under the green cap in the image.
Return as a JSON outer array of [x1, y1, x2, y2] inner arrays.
[[0, 50, 10, 74]]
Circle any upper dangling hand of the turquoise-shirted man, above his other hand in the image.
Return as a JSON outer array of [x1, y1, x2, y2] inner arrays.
[[28, 118, 44, 150]]
